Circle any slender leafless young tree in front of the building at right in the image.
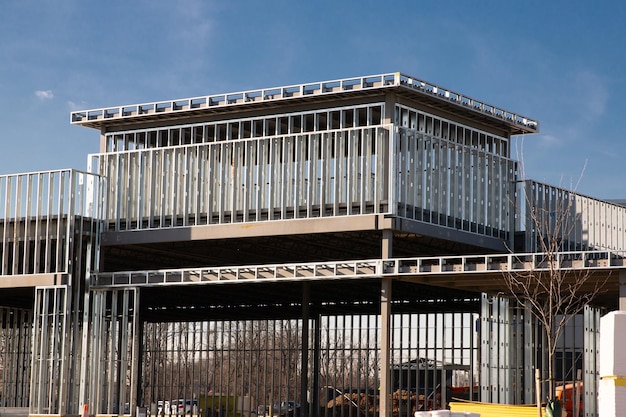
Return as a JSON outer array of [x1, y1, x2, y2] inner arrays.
[[504, 172, 608, 398]]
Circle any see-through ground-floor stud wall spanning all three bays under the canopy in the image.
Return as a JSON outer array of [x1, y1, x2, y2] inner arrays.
[[132, 313, 478, 417]]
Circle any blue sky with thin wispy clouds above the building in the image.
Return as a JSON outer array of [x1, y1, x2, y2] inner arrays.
[[0, 0, 626, 199]]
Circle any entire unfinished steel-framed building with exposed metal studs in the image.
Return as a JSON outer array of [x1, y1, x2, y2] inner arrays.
[[0, 73, 626, 417]]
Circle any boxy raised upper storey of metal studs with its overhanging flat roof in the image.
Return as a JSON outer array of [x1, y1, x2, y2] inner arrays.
[[64, 73, 623, 254]]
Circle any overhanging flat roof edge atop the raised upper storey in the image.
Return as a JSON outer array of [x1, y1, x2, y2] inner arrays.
[[70, 72, 539, 134]]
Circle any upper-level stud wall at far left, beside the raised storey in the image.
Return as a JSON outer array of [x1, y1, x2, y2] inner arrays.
[[0, 170, 103, 276]]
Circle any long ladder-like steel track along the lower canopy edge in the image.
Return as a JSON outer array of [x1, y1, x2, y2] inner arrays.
[[92, 251, 626, 287]]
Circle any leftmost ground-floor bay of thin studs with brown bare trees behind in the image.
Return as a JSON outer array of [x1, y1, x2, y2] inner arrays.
[[140, 320, 312, 417]]
